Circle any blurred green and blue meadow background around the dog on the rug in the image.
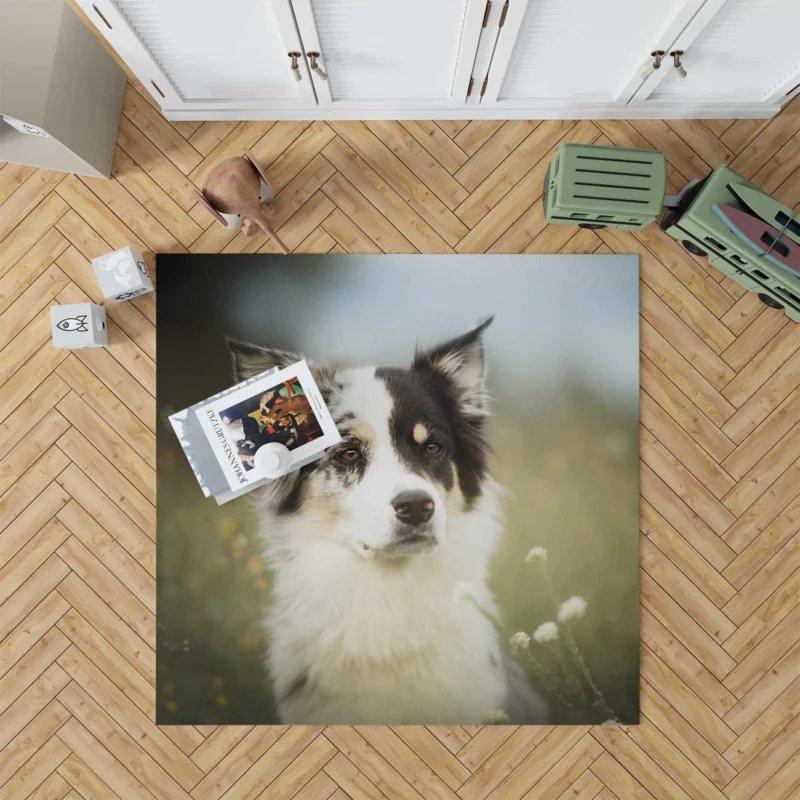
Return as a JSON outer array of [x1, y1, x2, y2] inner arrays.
[[157, 255, 639, 724]]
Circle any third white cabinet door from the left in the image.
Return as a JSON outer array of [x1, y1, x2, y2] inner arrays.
[[481, 0, 703, 113]]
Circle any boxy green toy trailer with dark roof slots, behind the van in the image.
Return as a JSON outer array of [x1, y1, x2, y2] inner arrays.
[[544, 144, 667, 231]]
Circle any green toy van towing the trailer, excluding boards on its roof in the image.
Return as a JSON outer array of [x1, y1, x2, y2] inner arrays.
[[661, 166, 800, 322]]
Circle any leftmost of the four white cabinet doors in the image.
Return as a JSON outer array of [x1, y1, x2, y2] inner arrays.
[[73, 0, 316, 111]]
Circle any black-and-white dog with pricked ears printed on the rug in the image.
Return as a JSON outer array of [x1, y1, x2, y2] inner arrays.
[[228, 319, 545, 725]]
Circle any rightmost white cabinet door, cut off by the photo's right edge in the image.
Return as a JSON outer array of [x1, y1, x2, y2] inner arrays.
[[633, 0, 800, 111]]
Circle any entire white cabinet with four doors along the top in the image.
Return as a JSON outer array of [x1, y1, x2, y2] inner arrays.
[[74, 0, 800, 120]]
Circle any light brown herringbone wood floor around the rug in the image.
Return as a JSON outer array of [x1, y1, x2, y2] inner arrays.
[[0, 61, 800, 800]]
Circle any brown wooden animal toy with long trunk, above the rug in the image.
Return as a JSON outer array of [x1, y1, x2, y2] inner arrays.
[[200, 150, 289, 253]]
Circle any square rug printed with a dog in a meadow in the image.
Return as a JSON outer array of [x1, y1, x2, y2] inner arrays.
[[157, 255, 639, 725]]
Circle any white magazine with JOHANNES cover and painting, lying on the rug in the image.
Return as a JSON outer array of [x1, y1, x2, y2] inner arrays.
[[170, 361, 341, 503]]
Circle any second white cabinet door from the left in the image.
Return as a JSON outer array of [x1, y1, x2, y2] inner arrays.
[[292, 0, 486, 111]]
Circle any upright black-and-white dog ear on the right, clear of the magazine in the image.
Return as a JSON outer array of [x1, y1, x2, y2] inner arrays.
[[413, 316, 494, 414]]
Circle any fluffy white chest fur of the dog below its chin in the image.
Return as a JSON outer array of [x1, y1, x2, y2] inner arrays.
[[269, 512, 507, 724]]
